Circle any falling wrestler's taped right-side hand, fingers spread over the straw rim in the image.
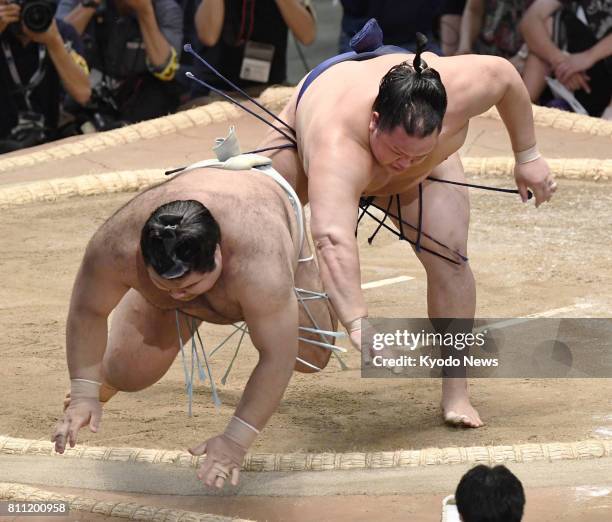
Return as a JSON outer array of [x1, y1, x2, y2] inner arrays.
[[188, 434, 247, 489]]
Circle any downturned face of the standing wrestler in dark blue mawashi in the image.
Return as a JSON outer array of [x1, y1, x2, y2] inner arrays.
[[370, 112, 439, 174]]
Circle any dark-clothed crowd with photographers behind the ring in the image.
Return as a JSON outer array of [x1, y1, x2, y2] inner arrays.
[[0, 0, 612, 153]]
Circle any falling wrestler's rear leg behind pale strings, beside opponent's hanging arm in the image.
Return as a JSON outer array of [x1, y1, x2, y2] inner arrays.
[[295, 240, 338, 373]]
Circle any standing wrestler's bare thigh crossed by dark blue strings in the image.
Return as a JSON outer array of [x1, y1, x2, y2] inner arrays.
[[375, 150, 470, 268]]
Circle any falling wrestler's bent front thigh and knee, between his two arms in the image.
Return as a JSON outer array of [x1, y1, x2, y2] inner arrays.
[[103, 289, 200, 391]]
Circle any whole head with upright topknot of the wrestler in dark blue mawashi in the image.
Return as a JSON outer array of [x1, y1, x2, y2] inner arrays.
[[370, 33, 446, 172]]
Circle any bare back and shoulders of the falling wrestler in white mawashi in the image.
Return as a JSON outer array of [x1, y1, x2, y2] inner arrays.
[[96, 168, 298, 324]]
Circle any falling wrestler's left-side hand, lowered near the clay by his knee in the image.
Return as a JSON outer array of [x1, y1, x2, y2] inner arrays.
[[51, 397, 102, 453]]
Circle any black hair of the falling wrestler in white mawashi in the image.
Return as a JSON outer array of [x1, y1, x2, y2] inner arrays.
[[140, 200, 221, 279]]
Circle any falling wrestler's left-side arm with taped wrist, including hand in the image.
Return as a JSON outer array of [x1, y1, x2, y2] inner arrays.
[[51, 232, 129, 453]]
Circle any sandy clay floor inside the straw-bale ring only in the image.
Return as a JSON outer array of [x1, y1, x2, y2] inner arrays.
[[0, 173, 612, 453]]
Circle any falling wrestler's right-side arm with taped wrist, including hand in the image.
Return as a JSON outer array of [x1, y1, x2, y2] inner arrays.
[[189, 260, 298, 488]]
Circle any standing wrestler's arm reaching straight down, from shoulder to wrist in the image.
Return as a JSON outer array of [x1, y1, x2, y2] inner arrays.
[[308, 139, 372, 348]]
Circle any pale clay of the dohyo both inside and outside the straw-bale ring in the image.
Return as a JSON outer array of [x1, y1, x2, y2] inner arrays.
[[0, 103, 612, 522]]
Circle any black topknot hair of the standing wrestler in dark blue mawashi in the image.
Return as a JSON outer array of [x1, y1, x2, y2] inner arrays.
[[372, 33, 446, 138]]
